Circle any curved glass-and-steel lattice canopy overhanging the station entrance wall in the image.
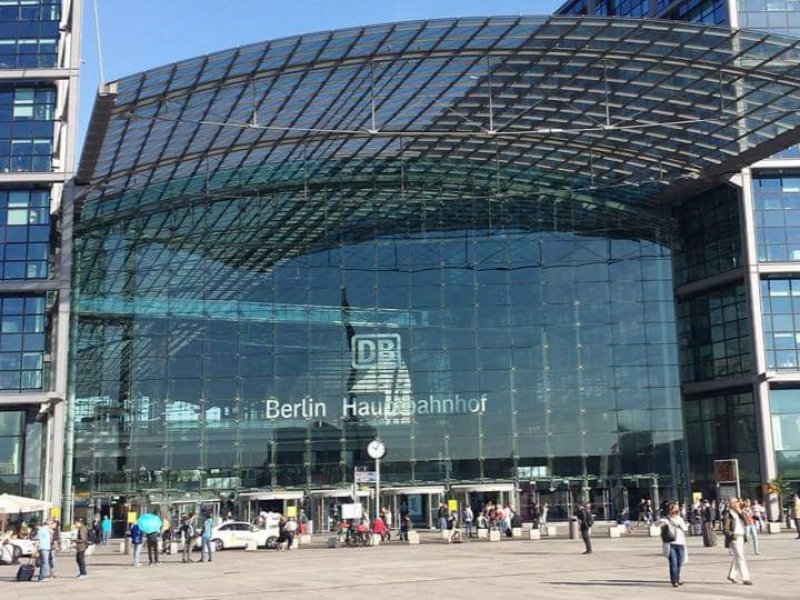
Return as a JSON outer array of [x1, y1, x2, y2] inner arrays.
[[78, 17, 800, 222]]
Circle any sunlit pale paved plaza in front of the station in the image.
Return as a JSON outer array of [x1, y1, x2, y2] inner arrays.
[[0, 533, 800, 600]]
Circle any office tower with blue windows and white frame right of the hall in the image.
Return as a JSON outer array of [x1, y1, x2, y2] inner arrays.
[[559, 0, 800, 510]]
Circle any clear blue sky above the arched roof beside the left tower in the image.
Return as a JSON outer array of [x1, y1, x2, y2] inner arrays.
[[78, 0, 564, 145]]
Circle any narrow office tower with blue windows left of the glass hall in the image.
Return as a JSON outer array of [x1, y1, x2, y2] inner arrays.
[[0, 0, 81, 504]]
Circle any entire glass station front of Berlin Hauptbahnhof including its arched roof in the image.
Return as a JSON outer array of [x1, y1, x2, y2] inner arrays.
[[65, 17, 800, 526]]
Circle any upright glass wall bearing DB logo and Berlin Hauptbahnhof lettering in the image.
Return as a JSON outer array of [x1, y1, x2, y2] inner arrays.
[[75, 190, 685, 502]]
